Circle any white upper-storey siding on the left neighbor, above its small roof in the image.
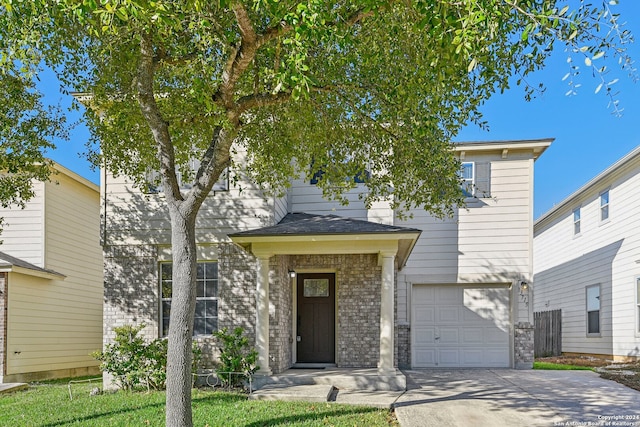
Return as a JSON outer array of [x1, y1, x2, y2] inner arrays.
[[0, 182, 45, 267]]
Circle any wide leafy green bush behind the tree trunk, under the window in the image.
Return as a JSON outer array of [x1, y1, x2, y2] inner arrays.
[[92, 323, 202, 390]]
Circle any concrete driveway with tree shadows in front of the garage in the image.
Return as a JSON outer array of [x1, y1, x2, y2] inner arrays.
[[395, 369, 640, 427]]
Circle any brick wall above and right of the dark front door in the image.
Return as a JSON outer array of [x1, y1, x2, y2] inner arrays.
[[290, 254, 382, 368]]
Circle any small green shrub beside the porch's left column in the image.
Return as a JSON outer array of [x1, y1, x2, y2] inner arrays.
[[213, 327, 260, 387]]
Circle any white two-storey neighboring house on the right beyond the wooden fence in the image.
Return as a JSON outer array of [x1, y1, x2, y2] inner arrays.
[[534, 147, 640, 360]]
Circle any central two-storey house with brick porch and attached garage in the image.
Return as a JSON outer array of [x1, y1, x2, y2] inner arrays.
[[101, 139, 551, 388]]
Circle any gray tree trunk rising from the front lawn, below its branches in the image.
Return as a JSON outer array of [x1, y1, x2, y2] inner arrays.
[[166, 203, 197, 427]]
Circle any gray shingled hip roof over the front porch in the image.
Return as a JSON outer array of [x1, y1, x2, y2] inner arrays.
[[230, 213, 420, 237]]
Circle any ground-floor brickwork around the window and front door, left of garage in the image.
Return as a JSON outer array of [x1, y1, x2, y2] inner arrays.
[[104, 243, 396, 373]]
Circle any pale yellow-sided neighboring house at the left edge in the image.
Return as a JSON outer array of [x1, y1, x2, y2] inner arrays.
[[0, 164, 103, 383]]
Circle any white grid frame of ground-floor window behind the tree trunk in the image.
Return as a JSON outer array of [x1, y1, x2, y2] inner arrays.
[[158, 260, 220, 337]]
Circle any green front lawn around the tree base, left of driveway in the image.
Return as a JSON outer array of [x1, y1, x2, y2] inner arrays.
[[0, 382, 397, 427]]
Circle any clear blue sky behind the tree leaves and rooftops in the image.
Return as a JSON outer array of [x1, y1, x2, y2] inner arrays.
[[42, 0, 640, 218]]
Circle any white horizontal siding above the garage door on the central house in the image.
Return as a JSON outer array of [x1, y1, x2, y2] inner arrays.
[[396, 156, 532, 283]]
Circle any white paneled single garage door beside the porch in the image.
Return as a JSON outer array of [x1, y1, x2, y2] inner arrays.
[[411, 285, 510, 368]]
